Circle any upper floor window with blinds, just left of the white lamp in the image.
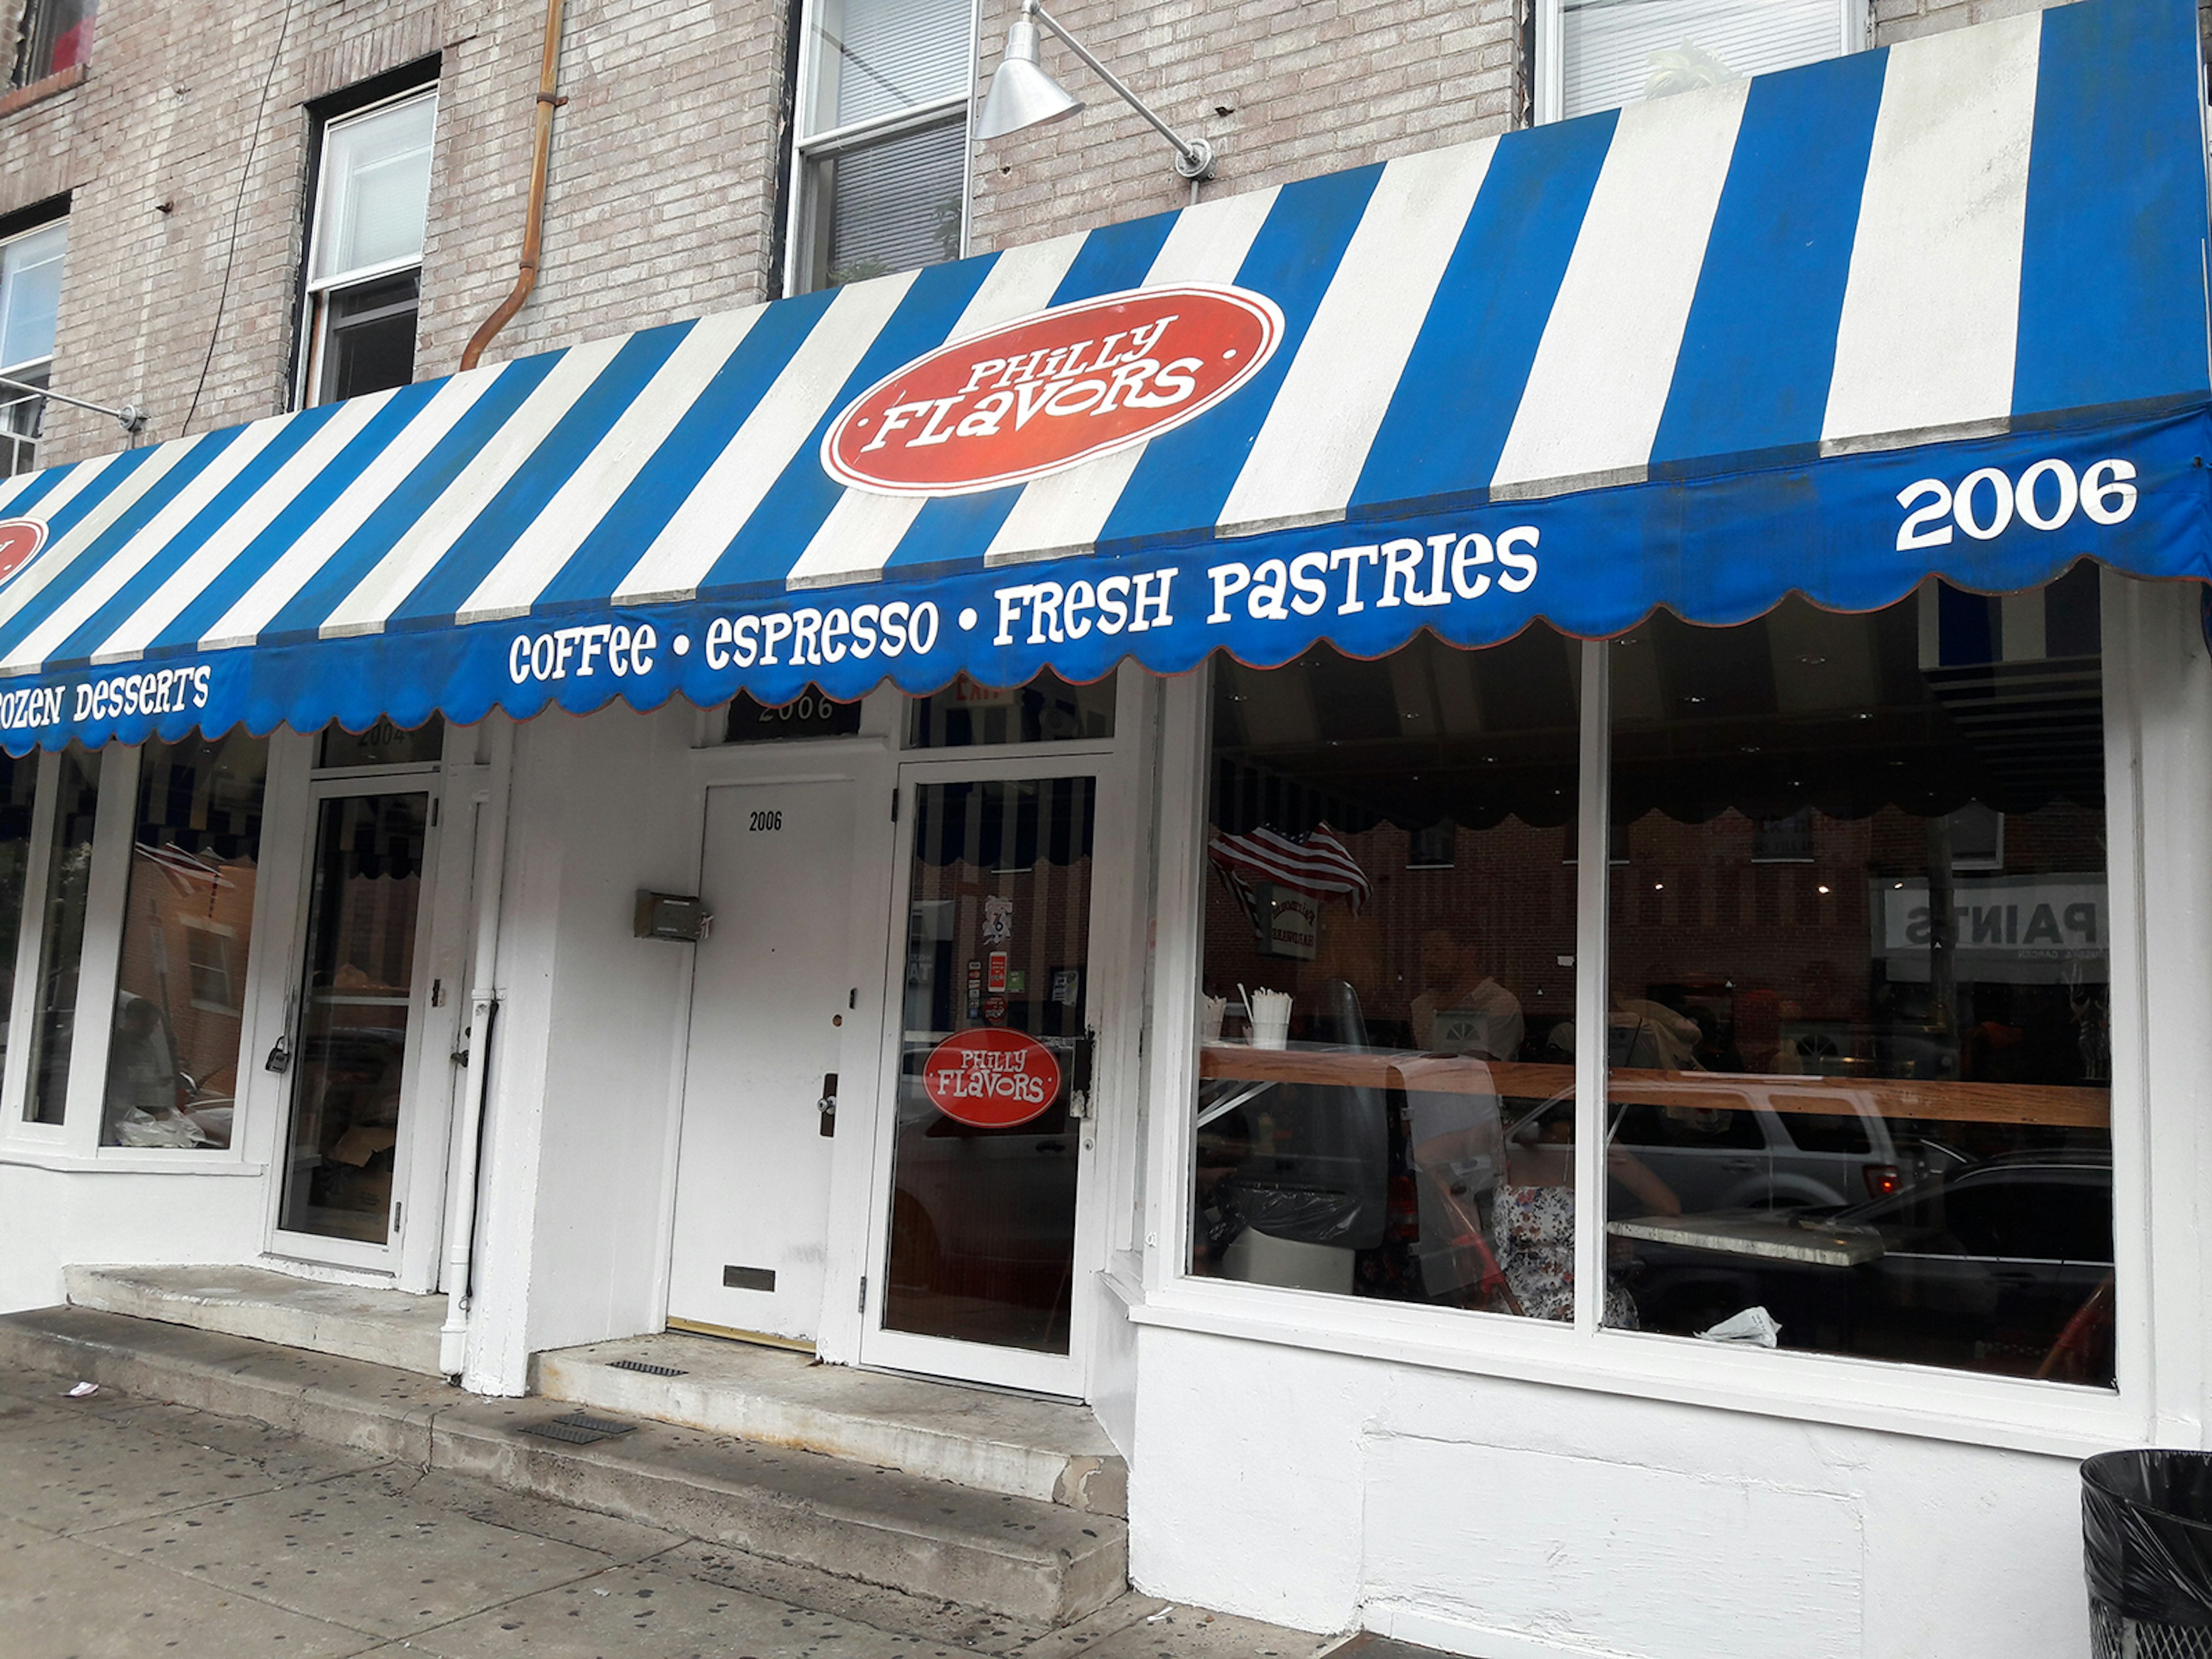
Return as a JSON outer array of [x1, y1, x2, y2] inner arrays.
[[790, 0, 975, 292]]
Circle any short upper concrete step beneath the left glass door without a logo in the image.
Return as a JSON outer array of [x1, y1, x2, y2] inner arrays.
[[62, 1267, 445, 1376]]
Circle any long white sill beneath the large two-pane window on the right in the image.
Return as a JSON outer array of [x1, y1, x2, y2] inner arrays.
[[1108, 1272, 2150, 1458]]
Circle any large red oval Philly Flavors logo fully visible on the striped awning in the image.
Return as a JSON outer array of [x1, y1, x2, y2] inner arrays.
[[823, 285, 1283, 495]]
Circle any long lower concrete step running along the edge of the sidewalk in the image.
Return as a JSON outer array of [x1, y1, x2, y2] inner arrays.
[[0, 1307, 1128, 1626]]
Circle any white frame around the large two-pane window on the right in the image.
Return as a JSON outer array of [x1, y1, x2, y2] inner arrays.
[[1141, 571, 2176, 1458]]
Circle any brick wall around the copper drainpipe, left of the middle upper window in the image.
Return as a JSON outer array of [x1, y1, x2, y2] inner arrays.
[[0, 0, 783, 463]]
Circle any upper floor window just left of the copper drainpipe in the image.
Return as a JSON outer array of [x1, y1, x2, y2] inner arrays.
[[301, 90, 438, 403]]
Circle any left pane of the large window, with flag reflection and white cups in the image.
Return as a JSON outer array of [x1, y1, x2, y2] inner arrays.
[[1190, 626, 1582, 1320]]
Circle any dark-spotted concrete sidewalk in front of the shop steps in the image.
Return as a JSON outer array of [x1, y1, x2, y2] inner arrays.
[[0, 1369, 1336, 1659]]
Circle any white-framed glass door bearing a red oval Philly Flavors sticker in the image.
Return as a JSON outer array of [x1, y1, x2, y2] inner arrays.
[[863, 777, 1097, 1393]]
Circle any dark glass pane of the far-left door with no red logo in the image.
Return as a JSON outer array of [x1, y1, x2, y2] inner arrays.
[[281, 794, 429, 1243]]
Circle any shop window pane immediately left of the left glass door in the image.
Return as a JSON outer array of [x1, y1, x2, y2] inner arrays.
[[100, 732, 268, 1146]]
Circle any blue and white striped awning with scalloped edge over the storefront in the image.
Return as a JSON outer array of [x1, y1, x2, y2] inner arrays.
[[0, 0, 2212, 752]]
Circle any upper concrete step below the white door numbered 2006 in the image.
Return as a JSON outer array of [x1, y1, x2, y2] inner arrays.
[[531, 1332, 1128, 1515]]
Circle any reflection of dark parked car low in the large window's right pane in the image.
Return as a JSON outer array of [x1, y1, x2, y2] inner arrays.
[[1633, 1150, 2112, 1387]]
